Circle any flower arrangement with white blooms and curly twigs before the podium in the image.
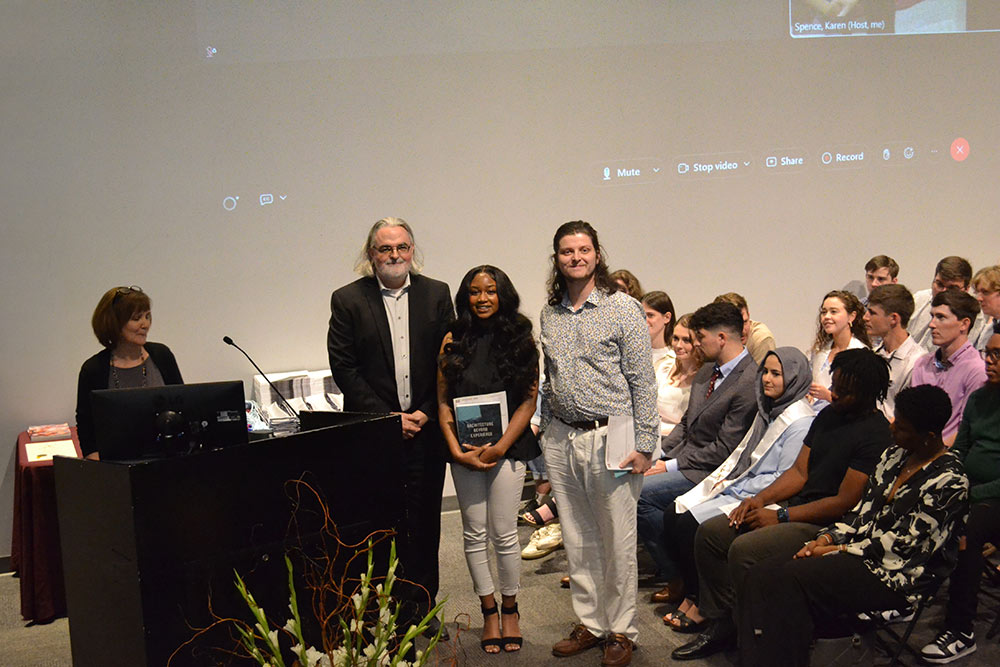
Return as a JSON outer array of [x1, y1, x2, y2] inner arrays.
[[174, 479, 456, 667]]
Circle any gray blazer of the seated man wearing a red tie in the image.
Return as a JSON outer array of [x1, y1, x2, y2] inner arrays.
[[663, 354, 757, 484]]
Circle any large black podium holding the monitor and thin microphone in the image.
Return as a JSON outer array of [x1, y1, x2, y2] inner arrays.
[[55, 413, 403, 667]]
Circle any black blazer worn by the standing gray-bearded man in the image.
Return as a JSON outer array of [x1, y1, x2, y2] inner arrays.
[[326, 274, 455, 422]]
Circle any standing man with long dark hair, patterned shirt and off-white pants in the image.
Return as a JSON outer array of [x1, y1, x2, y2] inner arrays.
[[541, 221, 659, 667]]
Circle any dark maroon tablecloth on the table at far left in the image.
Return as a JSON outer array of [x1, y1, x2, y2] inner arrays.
[[10, 428, 80, 623]]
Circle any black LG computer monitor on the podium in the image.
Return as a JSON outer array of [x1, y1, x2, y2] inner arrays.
[[90, 380, 248, 461]]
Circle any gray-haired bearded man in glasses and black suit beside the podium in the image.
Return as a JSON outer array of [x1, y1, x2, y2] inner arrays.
[[327, 218, 454, 630]]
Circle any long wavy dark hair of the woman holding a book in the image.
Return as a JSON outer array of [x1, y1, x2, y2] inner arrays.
[[438, 264, 538, 402]]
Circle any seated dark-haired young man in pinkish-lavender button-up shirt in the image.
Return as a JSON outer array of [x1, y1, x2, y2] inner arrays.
[[910, 289, 986, 446]]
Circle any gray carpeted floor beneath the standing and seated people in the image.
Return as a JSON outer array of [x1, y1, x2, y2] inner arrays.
[[0, 511, 1000, 667]]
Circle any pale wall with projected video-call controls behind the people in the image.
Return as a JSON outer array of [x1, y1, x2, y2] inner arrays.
[[0, 0, 1000, 553]]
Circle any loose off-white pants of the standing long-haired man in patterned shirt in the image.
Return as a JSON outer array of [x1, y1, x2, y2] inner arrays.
[[542, 419, 642, 641]]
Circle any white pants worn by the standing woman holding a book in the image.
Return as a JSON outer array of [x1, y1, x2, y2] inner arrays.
[[451, 459, 525, 597]]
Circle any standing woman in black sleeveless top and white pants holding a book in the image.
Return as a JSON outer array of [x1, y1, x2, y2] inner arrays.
[[438, 265, 540, 653]]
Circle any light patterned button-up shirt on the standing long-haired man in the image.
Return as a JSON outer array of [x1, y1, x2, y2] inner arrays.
[[541, 288, 660, 452]]
